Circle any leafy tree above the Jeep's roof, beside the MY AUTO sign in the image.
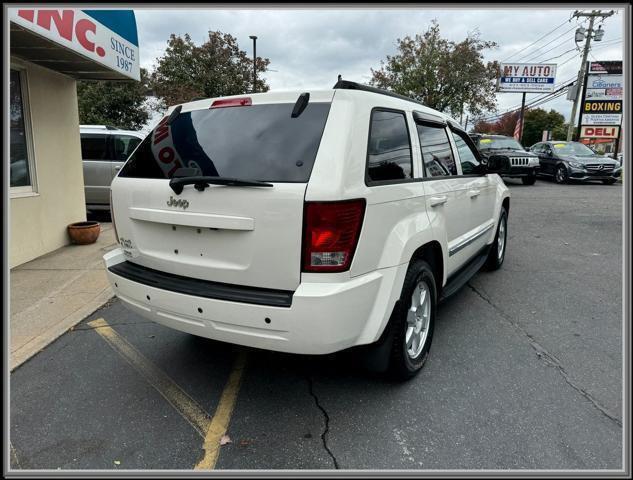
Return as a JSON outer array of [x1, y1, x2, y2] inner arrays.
[[370, 20, 499, 117]]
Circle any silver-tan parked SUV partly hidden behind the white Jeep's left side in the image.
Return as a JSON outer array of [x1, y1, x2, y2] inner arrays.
[[79, 125, 144, 210]]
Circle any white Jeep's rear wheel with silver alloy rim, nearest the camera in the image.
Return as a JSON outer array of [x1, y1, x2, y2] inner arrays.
[[388, 260, 437, 381]]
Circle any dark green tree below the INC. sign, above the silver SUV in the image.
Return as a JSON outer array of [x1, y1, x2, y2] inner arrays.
[[77, 68, 149, 130]]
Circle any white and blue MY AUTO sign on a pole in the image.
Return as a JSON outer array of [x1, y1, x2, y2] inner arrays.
[[497, 63, 556, 93]]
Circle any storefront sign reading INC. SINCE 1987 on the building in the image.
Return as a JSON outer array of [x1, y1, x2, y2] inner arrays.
[[9, 8, 141, 80]]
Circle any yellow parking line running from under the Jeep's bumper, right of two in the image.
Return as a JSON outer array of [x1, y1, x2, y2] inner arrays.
[[195, 351, 247, 470]]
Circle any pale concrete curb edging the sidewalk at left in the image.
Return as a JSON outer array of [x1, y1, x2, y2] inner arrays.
[[10, 285, 114, 371]]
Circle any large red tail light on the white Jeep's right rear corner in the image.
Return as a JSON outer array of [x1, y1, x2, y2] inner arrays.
[[303, 199, 365, 272]]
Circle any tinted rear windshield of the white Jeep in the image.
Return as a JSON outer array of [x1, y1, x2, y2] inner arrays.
[[119, 103, 330, 182]]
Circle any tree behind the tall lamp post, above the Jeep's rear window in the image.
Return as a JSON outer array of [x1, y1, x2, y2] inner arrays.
[[150, 31, 270, 107]]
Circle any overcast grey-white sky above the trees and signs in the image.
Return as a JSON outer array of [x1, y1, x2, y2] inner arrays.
[[135, 5, 624, 126]]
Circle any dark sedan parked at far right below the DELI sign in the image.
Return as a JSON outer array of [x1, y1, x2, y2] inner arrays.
[[530, 141, 622, 185]]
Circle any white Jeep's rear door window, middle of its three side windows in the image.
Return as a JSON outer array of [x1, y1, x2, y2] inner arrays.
[[416, 124, 457, 177]]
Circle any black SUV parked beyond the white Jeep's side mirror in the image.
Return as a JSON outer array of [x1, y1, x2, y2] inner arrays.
[[470, 133, 539, 185]]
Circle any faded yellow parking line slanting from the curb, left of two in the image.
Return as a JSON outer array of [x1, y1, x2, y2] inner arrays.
[[88, 318, 213, 438]]
